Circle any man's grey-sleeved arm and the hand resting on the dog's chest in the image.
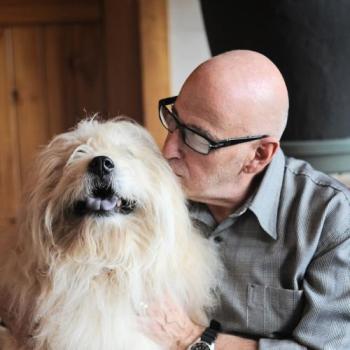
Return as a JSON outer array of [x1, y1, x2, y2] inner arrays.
[[141, 232, 350, 350]]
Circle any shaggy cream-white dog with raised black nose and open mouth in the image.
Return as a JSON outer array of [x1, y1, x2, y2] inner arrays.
[[0, 119, 219, 350]]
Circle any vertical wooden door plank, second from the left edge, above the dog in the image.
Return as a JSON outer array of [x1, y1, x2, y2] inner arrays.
[[12, 27, 49, 179]]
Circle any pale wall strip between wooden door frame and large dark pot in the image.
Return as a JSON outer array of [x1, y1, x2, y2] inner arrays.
[[168, 0, 211, 95]]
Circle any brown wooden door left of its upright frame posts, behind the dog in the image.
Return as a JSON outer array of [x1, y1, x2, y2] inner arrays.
[[0, 1, 106, 238]]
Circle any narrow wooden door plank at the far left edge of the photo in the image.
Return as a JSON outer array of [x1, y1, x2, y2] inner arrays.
[[0, 30, 21, 235]]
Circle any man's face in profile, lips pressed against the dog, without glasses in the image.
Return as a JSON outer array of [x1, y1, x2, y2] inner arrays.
[[163, 96, 250, 204]]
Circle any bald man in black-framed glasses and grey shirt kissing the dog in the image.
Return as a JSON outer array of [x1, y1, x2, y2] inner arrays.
[[144, 51, 350, 350]]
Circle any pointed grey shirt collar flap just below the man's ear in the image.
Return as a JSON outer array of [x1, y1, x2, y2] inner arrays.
[[249, 149, 285, 239]]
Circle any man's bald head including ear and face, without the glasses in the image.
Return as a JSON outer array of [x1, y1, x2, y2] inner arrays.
[[163, 50, 288, 209]]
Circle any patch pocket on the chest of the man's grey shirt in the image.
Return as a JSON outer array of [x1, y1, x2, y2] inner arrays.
[[247, 284, 304, 337]]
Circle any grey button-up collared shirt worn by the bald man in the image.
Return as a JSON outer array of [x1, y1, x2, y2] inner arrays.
[[191, 151, 350, 350]]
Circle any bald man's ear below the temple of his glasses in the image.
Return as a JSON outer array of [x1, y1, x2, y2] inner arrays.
[[243, 136, 280, 174]]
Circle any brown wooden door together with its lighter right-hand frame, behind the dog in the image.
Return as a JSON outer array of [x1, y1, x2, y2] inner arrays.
[[0, 0, 169, 246]]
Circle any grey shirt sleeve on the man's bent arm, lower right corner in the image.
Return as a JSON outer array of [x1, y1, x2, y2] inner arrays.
[[259, 231, 350, 350]]
